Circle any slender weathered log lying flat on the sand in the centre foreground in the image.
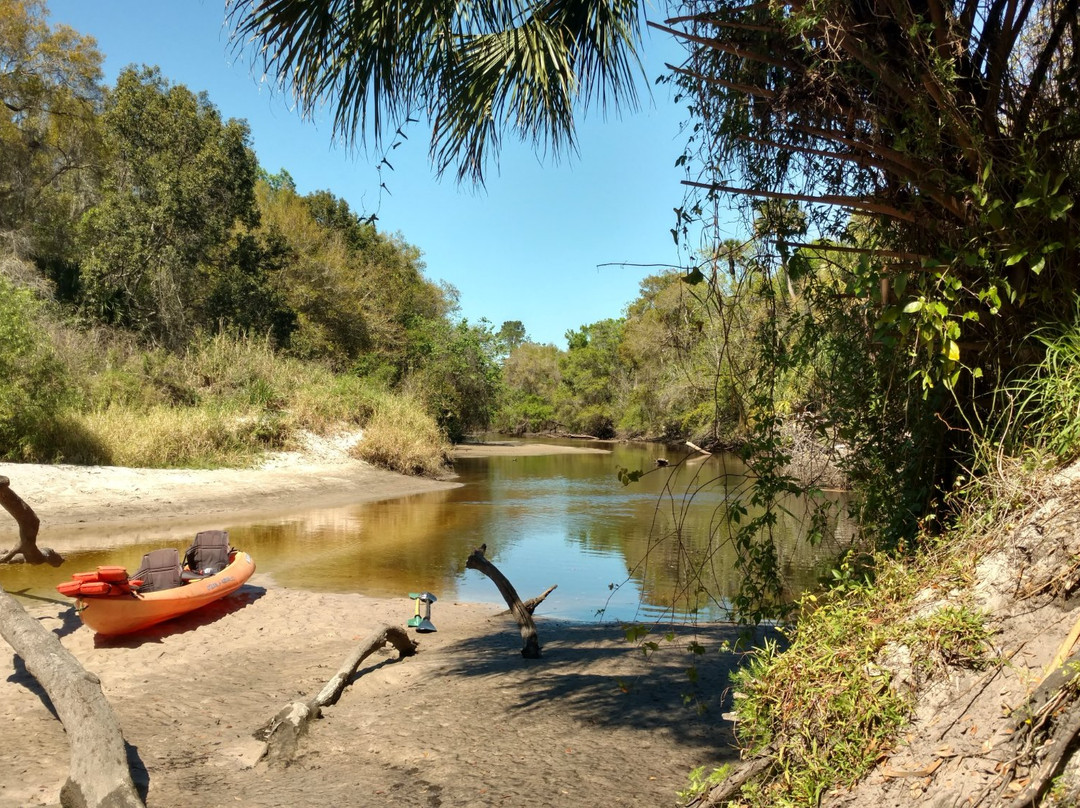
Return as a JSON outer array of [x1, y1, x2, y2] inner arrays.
[[254, 625, 417, 766]]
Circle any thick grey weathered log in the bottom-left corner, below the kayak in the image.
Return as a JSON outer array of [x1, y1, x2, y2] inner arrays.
[[0, 589, 143, 808]]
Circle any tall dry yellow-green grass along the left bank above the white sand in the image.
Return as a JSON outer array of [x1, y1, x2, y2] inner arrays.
[[17, 312, 445, 474]]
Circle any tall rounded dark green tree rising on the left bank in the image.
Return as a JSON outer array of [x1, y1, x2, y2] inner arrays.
[[79, 68, 257, 345]]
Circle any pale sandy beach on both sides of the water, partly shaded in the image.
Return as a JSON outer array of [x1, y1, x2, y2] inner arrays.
[[0, 437, 737, 808]]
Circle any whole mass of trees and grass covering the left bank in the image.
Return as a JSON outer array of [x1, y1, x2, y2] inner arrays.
[[0, 0, 496, 466]]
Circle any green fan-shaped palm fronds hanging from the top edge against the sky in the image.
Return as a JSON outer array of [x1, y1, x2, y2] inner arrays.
[[227, 0, 643, 183]]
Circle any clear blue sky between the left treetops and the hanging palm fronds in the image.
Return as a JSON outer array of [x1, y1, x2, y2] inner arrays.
[[49, 0, 685, 348]]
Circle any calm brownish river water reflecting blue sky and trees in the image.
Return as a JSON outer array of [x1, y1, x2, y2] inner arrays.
[[4, 442, 852, 625]]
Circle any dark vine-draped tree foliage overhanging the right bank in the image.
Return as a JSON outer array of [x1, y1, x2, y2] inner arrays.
[[657, 0, 1080, 529]]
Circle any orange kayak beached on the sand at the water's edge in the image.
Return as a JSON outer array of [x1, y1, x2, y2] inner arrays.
[[57, 551, 255, 634]]
